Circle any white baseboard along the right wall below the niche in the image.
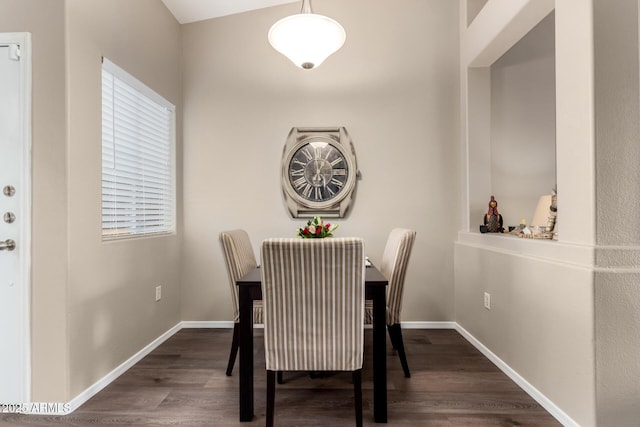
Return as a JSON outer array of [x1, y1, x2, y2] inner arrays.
[[456, 323, 580, 427]]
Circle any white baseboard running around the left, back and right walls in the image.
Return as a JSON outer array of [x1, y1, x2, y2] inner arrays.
[[38, 321, 579, 427]]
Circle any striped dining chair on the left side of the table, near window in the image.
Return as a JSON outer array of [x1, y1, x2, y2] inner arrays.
[[220, 230, 263, 376]]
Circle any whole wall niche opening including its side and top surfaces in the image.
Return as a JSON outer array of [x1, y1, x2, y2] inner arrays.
[[464, 1, 556, 236]]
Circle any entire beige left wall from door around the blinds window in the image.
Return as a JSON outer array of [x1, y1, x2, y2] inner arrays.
[[0, 0, 182, 402]]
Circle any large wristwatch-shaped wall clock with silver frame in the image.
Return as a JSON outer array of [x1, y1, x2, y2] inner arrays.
[[282, 127, 358, 218]]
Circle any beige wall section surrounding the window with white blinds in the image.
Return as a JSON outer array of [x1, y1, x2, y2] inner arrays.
[[66, 0, 182, 396]]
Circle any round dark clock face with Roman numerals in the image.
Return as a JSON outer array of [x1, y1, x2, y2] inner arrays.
[[287, 139, 351, 204]]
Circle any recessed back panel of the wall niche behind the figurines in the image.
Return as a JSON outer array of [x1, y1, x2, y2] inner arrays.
[[491, 13, 556, 229]]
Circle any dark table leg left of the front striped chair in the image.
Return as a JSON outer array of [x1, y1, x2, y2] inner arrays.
[[238, 286, 253, 421]]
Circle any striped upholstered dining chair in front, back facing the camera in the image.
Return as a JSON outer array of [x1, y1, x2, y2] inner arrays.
[[260, 238, 365, 427]]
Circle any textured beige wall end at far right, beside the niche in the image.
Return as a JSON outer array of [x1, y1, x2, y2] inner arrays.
[[594, 0, 640, 426]]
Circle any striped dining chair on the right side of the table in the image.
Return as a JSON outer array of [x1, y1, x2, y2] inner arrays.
[[365, 228, 416, 378]]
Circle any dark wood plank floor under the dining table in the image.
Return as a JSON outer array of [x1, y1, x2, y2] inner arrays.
[[0, 329, 560, 427]]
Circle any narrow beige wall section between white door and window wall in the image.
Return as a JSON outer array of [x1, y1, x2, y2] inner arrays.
[[0, 0, 69, 402]]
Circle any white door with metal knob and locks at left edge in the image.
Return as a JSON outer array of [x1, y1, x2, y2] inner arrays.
[[0, 33, 31, 404]]
